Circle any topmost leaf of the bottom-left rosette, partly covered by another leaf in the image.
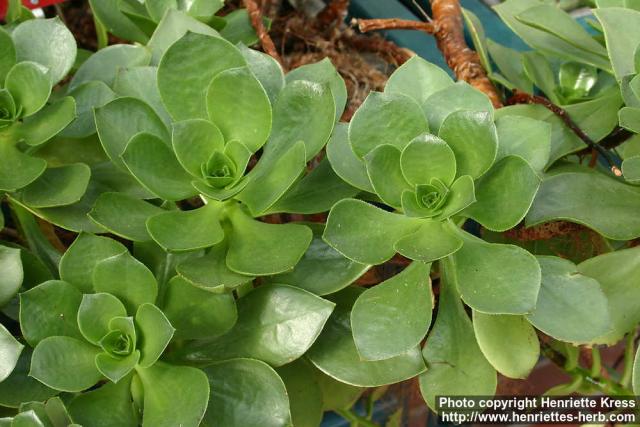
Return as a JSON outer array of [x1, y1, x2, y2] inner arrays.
[[60, 233, 127, 293]]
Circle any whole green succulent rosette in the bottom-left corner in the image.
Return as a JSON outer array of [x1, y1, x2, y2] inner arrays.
[[13, 234, 215, 426]]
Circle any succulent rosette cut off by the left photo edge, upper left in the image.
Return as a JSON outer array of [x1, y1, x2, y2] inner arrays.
[[0, 18, 82, 201]]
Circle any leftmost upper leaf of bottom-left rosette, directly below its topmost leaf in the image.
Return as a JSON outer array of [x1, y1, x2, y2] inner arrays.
[[20, 280, 82, 347]]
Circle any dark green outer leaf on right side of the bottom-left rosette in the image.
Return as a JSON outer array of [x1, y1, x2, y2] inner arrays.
[[163, 276, 238, 339]]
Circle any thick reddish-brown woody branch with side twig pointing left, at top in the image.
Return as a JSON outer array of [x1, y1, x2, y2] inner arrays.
[[356, 0, 502, 108]]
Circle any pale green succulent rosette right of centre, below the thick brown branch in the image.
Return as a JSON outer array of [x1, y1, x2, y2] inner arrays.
[[324, 57, 549, 314]]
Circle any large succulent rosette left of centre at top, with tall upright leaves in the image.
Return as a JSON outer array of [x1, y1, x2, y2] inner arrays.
[[84, 33, 357, 275]]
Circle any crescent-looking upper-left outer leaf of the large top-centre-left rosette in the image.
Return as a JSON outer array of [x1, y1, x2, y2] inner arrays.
[[95, 97, 169, 170]]
